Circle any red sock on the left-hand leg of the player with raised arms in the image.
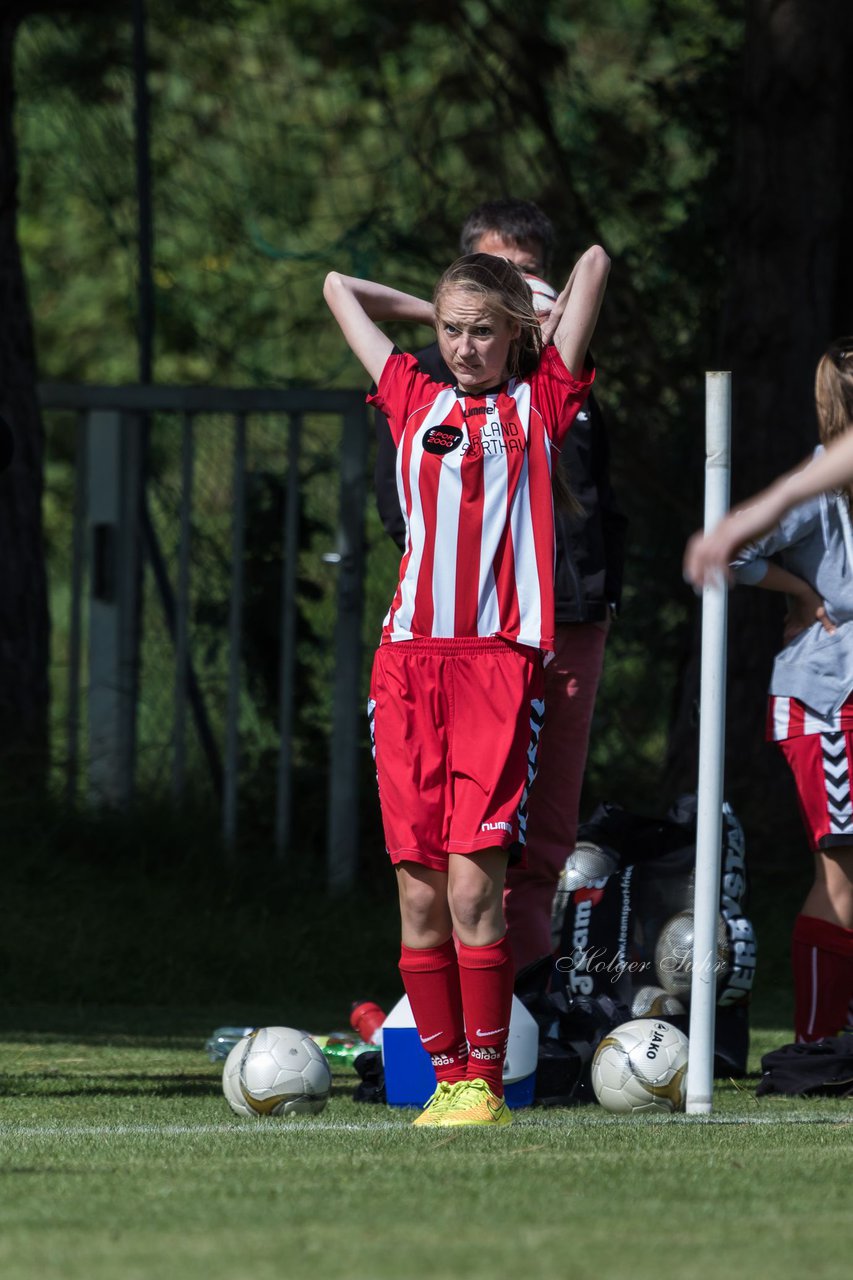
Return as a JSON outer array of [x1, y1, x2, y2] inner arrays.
[[400, 938, 467, 1084]]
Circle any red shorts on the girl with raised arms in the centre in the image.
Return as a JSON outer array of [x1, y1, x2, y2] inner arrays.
[[368, 636, 543, 870]]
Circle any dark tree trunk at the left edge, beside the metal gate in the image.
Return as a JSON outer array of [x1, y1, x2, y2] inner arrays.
[[0, 18, 49, 792]]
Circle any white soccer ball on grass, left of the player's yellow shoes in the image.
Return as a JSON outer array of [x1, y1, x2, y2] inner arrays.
[[239, 1027, 332, 1116]]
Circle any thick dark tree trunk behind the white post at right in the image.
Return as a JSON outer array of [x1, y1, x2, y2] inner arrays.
[[669, 0, 853, 858]]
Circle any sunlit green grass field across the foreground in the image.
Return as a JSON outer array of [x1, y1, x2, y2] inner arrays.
[[0, 1006, 853, 1280]]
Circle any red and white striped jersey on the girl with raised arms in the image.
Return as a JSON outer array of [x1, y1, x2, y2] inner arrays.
[[368, 347, 594, 650]]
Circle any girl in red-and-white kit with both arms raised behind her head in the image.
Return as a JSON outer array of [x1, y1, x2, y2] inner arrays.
[[324, 246, 610, 1125]]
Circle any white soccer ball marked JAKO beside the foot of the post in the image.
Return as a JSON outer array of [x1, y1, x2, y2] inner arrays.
[[592, 1018, 688, 1115]]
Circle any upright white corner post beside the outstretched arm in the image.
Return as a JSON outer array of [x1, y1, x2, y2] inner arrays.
[[686, 372, 731, 1115]]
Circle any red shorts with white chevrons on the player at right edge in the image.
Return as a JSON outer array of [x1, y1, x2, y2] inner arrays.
[[779, 730, 853, 851]]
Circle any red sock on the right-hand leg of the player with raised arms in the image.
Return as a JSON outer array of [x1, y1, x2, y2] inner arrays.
[[459, 934, 515, 1098]]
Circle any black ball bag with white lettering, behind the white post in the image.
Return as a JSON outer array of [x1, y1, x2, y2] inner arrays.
[[552, 795, 756, 1075]]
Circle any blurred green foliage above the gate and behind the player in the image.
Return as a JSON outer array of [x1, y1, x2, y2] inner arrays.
[[11, 0, 742, 829]]
